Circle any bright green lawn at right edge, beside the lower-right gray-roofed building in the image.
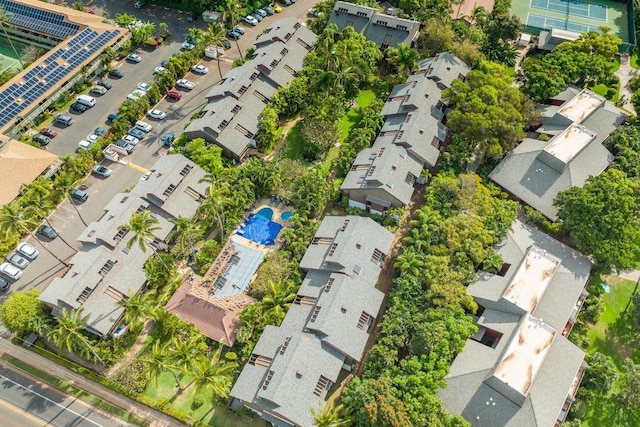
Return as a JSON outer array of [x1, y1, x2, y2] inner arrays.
[[586, 276, 639, 367]]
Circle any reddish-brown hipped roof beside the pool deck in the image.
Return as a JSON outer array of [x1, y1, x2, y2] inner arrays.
[[165, 279, 254, 347]]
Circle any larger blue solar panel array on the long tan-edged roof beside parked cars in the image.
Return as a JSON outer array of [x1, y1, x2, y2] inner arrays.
[[0, 28, 120, 127]]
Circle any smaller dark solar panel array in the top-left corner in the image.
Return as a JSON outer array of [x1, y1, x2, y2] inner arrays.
[[0, 0, 80, 39]]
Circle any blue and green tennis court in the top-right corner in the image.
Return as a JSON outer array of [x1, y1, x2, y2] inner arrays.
[[511, 0, 635, 51]]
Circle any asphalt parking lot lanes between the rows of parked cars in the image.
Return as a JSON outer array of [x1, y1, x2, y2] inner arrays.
[[5, 0, 315, 295]]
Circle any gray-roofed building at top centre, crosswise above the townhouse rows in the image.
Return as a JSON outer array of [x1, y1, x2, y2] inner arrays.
[[329, 1, 420, 48]]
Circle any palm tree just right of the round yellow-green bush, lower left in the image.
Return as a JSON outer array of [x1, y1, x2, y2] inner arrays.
[[47, 308, 102, 363]]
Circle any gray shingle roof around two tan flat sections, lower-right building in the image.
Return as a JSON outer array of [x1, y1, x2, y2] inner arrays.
[[438, 221, 591, 427]]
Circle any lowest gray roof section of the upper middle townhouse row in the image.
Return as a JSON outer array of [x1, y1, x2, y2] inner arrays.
[[340, 144, 422, 207]]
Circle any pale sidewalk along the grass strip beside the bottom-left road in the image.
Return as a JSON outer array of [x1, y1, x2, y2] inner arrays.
[[0, 339, 183, 427]]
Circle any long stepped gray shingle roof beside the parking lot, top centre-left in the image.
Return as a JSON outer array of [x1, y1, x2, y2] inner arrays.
[[185, 17, 316, 159]]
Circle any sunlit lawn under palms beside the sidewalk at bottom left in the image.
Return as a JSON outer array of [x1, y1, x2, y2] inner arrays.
[[144, 372, 264, 427]]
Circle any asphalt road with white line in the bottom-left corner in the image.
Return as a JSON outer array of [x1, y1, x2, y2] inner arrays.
[[0, 367, 130, 427]]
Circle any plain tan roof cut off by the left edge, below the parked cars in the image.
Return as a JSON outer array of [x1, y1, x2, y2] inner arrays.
[[0, 140, 58, 206]]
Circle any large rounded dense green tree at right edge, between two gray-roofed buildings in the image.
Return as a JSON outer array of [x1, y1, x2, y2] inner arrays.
[[553, 169, 640, 271]]
